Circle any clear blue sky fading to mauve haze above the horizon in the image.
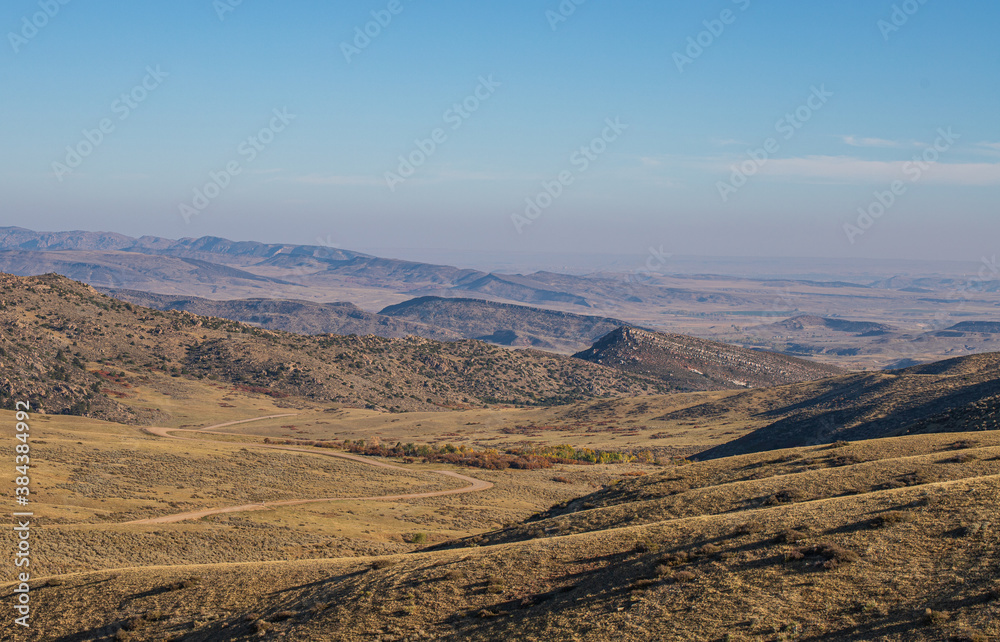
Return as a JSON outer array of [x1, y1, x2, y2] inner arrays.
[[0, 0, 1000, 261]]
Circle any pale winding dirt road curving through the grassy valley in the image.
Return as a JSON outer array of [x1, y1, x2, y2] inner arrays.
[[125, 414, 493, 524]]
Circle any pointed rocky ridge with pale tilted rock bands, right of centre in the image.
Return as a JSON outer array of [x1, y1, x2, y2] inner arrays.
[[574, 327, 843, 391]]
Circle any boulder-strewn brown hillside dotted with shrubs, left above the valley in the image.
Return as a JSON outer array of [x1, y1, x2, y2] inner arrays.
[[0, 268, 665, 422]]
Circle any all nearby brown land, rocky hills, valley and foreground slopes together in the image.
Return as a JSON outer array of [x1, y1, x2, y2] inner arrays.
[[0, 268, 1000, 642]]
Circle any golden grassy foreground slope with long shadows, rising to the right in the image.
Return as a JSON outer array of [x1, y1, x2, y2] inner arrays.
[[11, 433, 1000, 642]]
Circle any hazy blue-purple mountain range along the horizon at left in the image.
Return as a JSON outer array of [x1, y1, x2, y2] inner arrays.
[[0, 227, 749, 309]]
